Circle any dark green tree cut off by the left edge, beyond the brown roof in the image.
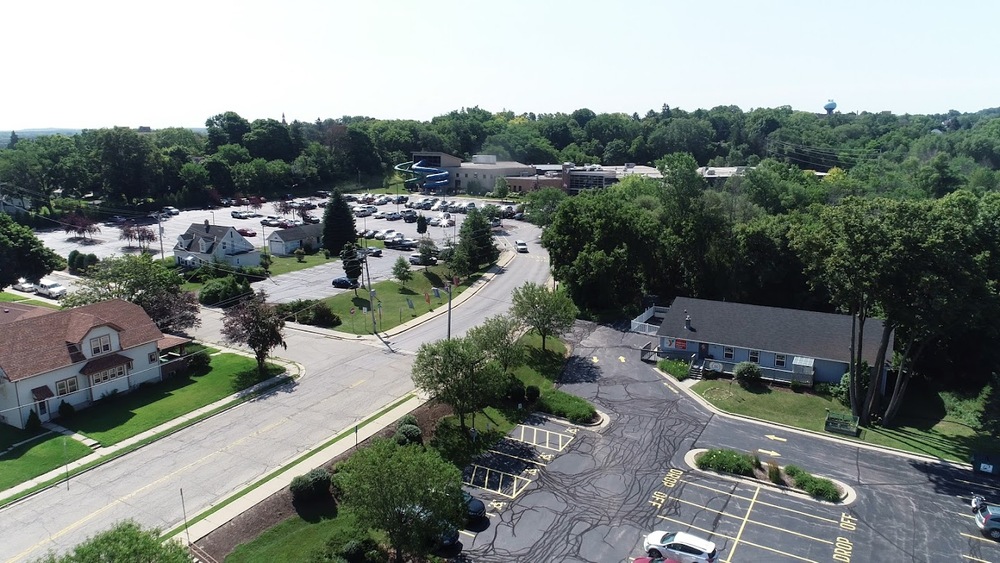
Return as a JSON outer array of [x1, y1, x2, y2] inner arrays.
[[0, 213, 66, 289]]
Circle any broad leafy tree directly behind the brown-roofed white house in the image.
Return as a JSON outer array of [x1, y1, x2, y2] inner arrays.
[[64, 254, 201, 332]]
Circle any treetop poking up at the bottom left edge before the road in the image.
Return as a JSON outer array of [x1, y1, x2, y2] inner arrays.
[[32, 520, 191, 563]]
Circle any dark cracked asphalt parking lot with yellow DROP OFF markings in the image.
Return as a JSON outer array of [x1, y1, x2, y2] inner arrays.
[[463, 323, 1000, 563]]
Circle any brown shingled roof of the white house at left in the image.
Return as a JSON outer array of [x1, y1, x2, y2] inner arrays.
[[0, 299, 163, 381]]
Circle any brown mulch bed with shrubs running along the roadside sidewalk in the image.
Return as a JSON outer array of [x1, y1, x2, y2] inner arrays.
[[194, 403, 452, 561]]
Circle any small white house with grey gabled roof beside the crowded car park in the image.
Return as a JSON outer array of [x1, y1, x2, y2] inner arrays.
[[174, 220, 260, 268]]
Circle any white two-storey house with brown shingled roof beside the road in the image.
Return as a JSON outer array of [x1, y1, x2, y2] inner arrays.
[[0, 299, 190, 428]]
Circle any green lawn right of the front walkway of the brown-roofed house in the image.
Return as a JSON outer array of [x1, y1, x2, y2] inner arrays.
[[61, 349, 274, 446]]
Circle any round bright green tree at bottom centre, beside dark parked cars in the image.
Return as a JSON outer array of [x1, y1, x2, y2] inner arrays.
[[334, 439, 467, 561]]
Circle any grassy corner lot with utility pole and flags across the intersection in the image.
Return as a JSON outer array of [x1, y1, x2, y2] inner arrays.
[[324, 264, 482, 334]]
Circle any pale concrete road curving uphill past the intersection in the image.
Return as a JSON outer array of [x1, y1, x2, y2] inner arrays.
[[0, 223, 548, 562]]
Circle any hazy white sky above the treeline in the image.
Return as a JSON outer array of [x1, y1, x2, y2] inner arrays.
[[7, 0, 1000, 130]]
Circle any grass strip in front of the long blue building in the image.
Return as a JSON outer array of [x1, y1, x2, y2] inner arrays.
[[693, 379, 1000, 462]]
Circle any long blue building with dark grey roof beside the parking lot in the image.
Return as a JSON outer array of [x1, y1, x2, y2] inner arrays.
[[656, 297, 892, 385]]
